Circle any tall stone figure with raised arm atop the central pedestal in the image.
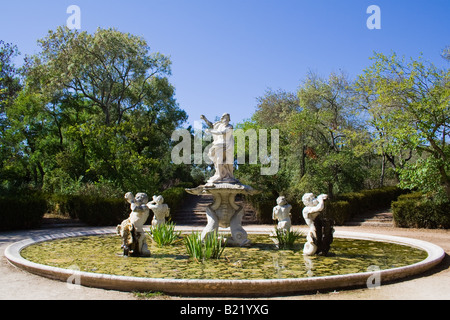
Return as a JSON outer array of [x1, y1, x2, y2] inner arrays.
[[201, 113, 237, 186]]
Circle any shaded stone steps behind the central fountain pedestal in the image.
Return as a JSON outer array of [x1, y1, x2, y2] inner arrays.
[[171, 194, 258, 226]]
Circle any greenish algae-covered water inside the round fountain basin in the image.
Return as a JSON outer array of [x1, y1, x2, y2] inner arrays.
[[21, 235, 427, 280]]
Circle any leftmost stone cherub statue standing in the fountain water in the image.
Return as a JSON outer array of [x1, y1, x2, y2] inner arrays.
[[116, 192, 150, 257]]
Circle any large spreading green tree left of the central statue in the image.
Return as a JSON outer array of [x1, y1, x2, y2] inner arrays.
[[8, 27, 187, 193]]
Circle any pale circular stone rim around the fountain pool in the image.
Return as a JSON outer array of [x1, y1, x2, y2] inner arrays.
[[5, 228, 445, 297]]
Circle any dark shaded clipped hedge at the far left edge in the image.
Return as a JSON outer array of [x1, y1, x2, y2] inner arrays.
[[0, 194, 47, 231]]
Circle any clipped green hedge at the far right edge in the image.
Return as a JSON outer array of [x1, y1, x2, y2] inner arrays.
[[392, 193, 450, 229]]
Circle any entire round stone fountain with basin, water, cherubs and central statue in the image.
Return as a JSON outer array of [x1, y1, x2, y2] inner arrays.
[[5, 114, 445, 296]]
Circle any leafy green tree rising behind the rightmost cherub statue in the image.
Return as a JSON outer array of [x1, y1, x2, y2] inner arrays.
[[289, 73, 364, 197]]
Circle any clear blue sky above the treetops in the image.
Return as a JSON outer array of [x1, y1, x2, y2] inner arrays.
[[0, 0, 450, 124]]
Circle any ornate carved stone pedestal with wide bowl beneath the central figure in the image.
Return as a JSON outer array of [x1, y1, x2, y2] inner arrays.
[[186, 182, 259, 246]]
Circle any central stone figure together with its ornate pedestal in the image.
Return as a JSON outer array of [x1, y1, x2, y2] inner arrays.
[[186, 113, 258, 246]]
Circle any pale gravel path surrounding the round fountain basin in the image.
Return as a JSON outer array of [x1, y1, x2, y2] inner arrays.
[[0, 225, 450, 300]]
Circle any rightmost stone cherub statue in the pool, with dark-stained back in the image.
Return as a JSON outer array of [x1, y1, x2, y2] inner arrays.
[[302, 193, 334, 256]]
